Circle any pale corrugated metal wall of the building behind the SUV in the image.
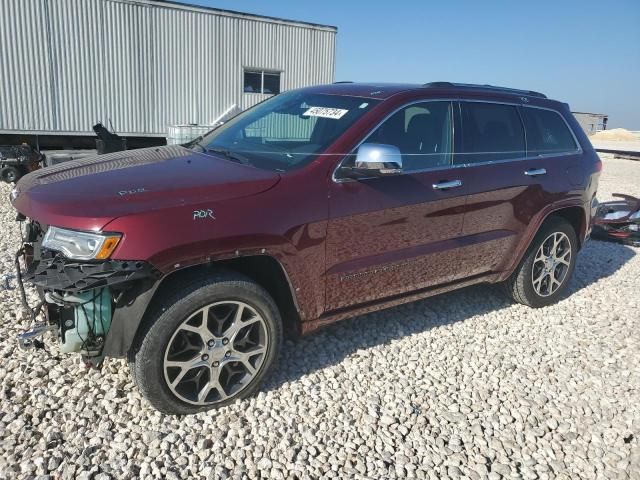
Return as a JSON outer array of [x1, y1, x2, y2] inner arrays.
[[0, 0, 336, 136]]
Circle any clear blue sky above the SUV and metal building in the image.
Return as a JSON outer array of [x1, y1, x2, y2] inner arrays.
[[178, 0, 640, 130]]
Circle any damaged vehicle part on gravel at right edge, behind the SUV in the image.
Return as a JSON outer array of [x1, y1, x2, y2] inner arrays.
[[591, 193, 640, 247]]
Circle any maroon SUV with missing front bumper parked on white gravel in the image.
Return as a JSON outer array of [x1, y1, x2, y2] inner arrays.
[[12, 82, 601, 413]]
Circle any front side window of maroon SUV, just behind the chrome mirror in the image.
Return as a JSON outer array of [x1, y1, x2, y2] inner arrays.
[[366, 102, 451, 171]]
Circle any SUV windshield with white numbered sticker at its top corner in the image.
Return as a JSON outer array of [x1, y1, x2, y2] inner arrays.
[[192, 91, 378, 171]]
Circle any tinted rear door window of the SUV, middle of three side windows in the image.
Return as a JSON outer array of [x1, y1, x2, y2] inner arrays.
[[455, 102, 525, 164]]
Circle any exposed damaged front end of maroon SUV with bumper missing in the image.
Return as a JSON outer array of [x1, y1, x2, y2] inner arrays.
[[16, 216, 159, 367]]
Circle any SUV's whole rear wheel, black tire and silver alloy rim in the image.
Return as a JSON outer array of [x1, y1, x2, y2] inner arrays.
[[504, 217, 578, 308]]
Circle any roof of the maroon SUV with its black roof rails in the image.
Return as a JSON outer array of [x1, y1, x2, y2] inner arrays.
[[308, 82, 547, 100]]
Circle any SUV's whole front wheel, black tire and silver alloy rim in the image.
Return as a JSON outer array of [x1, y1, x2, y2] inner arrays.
[[130, 273, 282, 414]]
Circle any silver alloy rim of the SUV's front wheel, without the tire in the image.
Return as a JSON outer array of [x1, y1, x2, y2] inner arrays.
[[163, 301, 268, 405]]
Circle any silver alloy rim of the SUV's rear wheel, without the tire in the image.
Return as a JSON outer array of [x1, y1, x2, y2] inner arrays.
[[531, 232, 572, 297]]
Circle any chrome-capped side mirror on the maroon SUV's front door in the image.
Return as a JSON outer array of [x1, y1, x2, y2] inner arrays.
[[343, 143, 402, 178]]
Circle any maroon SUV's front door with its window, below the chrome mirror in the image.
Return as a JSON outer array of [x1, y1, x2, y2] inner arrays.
[[326, 101, 465, 311]]
